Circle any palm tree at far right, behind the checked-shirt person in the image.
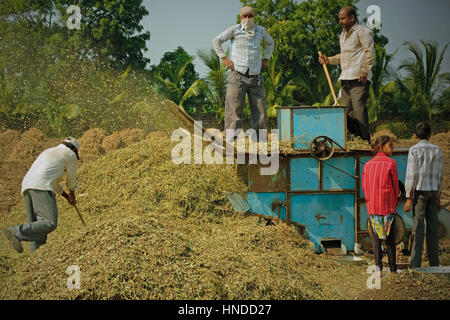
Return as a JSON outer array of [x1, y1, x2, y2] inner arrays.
[[397, 41, 450, 120]]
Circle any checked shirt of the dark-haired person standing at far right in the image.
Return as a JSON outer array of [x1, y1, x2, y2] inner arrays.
[[405, 140, 443, 198]]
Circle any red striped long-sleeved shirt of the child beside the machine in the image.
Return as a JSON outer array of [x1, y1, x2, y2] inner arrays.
[[362, 152, 399, 215]]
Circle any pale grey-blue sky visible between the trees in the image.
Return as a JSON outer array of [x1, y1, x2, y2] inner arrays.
[[141, 0, 450, 77]]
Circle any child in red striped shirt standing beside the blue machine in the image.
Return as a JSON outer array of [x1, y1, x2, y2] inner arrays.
[[362, 136, 399, 276]]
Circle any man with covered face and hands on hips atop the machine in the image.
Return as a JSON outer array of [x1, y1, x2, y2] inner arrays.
[[213, 6, 274, 139]]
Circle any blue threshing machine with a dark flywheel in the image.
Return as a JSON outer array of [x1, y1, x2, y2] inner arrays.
[[228, 106, 412, 252]]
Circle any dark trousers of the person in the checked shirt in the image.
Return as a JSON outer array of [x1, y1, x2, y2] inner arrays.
[[409, 190, 439, 268]]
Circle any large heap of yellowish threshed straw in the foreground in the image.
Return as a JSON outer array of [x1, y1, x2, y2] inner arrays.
[[0, 132, 367, 299]]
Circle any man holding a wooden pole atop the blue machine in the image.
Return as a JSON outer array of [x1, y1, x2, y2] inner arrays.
[[319, 6, 375, 141]]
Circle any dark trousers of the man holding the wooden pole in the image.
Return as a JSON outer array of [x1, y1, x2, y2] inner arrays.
[[341, 79, 370, 141]]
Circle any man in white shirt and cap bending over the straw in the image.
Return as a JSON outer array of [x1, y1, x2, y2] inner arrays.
[[3, 138, 79, 253]]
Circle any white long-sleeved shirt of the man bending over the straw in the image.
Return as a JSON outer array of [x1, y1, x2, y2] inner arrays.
[[22, 144, 77, 194]]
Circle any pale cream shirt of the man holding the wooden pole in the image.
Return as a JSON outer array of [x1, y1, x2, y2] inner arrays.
[[328, 24, 375, 81]]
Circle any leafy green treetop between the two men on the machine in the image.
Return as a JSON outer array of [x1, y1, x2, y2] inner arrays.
[[241, 0, 357, 84]]
